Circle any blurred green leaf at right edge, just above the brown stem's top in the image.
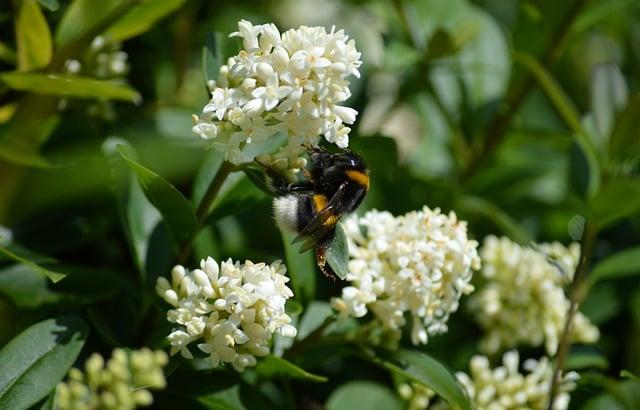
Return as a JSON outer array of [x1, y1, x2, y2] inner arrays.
[[589, 177, 640, 229]]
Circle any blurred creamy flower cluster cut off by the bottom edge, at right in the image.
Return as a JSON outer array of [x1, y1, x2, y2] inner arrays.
[[456, 350, 578, 410]]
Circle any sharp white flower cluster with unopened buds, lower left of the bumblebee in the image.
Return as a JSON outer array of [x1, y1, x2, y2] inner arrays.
[[156, 258, 296, 372]]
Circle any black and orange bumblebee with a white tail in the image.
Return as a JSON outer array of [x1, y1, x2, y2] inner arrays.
[[273, 147, 369, 278]]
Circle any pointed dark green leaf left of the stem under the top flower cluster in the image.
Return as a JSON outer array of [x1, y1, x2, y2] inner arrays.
[[118, 145, 198, 244]]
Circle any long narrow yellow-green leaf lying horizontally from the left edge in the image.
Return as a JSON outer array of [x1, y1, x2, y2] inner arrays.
[[0, 72, 141, 104]]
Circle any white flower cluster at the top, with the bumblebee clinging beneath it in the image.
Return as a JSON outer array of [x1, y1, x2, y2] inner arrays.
[[193, 20, 362, 168]]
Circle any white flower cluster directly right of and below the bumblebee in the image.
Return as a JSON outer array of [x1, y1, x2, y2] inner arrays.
[[332, 206, 480, 345]]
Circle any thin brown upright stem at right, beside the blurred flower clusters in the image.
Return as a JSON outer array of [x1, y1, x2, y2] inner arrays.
[[547, 223, 596, 410]]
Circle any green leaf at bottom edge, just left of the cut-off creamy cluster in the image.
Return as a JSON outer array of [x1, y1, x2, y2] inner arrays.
[[365, 349, 471, 410]]
